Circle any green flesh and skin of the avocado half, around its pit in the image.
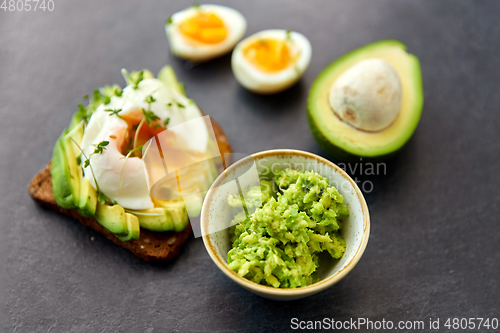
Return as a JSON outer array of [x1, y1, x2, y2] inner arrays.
[[307, 40, 424, 161]]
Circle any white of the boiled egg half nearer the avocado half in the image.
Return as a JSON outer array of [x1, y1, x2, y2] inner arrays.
[[231, 29, 311, 94]]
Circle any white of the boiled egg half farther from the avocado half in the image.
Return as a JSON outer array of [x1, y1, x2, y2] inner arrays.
[[165, 5, 247, 62]]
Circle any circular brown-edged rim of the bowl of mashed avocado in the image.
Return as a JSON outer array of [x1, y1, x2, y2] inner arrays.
[[200, 149, 370, 297]]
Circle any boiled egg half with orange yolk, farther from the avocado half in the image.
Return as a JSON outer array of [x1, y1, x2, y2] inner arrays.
[[165, 5, 247, 62]]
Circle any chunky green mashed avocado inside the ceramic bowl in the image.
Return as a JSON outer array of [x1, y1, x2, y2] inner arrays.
[[227, 169, 349, 288]]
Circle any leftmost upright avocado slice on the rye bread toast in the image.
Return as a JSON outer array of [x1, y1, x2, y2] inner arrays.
[[50, 133, 75, 209]]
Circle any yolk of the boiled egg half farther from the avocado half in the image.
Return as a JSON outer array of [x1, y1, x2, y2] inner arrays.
[[179, 12, 227, 44]]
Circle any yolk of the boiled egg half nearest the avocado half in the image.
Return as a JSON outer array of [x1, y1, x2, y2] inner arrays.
[[243, 39, 295, 73]]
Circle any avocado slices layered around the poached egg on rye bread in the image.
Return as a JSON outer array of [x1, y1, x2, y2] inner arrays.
[[51, 66, 199, 241]]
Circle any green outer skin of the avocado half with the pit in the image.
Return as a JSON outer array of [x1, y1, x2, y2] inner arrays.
[[307, 39, 424, 162]]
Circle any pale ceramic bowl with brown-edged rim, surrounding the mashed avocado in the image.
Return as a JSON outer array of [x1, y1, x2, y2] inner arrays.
[[200, 149, 370, 300]]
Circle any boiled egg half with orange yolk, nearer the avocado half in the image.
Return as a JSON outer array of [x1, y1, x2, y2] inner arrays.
[[231, 30, 311, 94]]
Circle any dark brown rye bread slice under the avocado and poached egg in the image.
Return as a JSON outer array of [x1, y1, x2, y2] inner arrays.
[[28, 120, 231, 263]]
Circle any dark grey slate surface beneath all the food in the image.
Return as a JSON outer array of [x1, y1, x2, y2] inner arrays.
[[0, 0, 500, 332]]
